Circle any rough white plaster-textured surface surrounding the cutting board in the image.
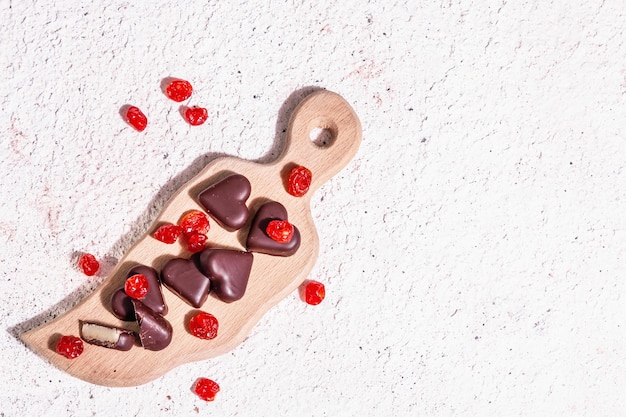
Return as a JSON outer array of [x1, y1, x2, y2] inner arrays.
[[0, 0, 626, 417]]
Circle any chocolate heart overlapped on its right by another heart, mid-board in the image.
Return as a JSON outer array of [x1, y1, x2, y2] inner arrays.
[[161, 256, 211, 308]]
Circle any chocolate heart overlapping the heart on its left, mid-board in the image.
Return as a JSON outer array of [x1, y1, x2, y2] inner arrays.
[[198, 249, 253, 303]]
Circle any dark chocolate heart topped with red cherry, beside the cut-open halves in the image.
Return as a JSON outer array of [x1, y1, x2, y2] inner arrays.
[[111, 265, 167, 321]]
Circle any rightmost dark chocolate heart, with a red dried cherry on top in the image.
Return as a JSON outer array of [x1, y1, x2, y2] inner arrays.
[[246, 201, 300, 256]]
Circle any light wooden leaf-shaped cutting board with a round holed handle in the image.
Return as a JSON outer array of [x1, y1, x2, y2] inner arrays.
[[21, 91, 361, 386]]
